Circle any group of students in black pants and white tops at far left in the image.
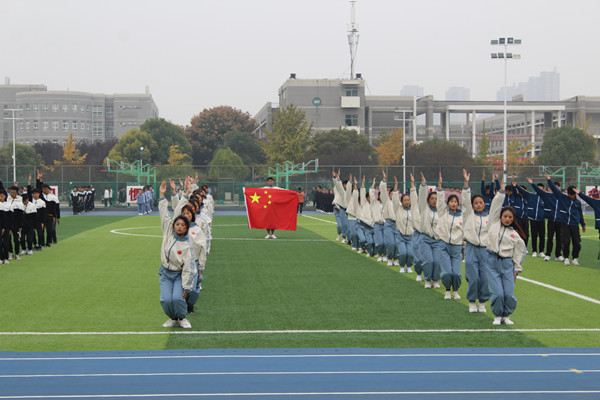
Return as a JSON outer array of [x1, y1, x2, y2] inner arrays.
[[0, 172, 60, 264]]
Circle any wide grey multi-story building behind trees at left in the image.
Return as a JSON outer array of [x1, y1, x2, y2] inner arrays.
[[0, 85, 158, 146]]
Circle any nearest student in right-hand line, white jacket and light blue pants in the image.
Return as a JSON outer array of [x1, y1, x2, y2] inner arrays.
[[487, 177, 527, 325]]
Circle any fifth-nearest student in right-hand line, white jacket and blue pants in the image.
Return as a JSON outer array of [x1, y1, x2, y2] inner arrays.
[[392, 177, 418, 274]]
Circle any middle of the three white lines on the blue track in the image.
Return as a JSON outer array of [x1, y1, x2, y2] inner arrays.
[[0, 369, 600, 379]]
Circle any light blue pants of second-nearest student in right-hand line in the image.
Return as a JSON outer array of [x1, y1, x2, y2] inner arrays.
[[465, 242, 490, 303]]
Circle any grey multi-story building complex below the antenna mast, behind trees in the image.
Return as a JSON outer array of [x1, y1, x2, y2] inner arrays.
[[255, 74, 600, 156]]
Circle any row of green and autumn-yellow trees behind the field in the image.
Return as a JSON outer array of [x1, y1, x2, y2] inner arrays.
[[0, 105, 598, 180]]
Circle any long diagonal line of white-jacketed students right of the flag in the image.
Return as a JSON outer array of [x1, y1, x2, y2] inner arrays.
[[333, 170, 524, 325]]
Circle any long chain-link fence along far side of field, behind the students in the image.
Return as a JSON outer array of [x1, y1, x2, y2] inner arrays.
[[0, 165, 600, 206]]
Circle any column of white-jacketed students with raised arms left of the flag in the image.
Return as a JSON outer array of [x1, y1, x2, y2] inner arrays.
[[158, 177, 214, 329]]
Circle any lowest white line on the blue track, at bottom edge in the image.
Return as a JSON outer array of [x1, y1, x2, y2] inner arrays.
[[0, 390, 600, 399]]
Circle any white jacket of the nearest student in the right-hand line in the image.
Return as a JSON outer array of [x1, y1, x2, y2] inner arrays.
[[486, 191, 527, 272]]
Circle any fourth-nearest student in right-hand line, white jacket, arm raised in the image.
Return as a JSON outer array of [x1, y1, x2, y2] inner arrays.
[[419, 173, 441, 289]]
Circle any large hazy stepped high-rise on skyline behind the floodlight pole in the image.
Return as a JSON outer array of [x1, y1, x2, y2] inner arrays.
[[496, 68, 560, 101]]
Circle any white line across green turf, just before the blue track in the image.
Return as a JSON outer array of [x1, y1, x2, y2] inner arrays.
[[0, 328, 600, 336]]
